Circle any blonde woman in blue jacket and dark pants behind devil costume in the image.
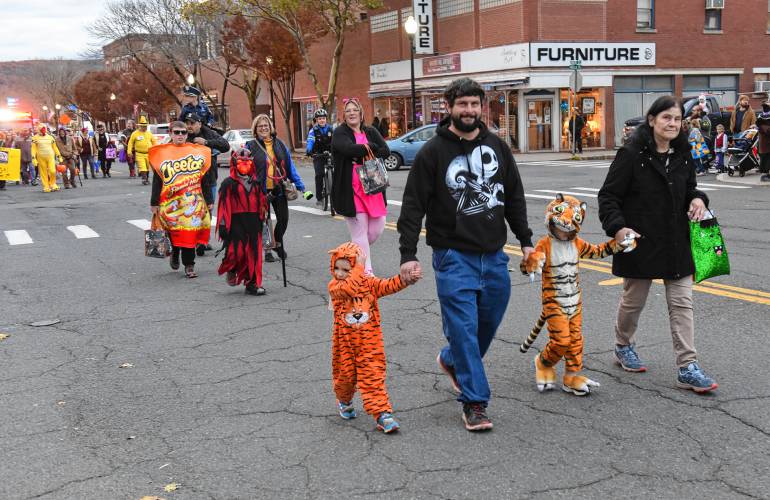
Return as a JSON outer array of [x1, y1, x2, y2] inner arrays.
[[245, 114, 313, 262]]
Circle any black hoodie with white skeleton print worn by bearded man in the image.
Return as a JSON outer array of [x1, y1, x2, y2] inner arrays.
[[398, 117, 532, 263]]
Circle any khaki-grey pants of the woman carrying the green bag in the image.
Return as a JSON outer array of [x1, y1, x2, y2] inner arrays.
[[615, 276, 697, 368]]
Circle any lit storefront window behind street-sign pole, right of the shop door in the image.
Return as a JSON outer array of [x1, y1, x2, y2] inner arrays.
[[559, 89, 604, 151]]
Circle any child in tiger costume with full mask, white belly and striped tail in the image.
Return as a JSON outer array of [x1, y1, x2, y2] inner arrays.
[[520, 194, 636, 396]]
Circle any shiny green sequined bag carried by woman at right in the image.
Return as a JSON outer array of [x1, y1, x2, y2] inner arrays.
[[690, 211, 730, 283]]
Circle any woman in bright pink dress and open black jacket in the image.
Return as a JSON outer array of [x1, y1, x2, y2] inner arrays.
[[332, 99, 390, 273]]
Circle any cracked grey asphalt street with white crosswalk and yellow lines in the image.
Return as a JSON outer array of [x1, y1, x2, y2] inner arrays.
[[0, 161, 770, 500]]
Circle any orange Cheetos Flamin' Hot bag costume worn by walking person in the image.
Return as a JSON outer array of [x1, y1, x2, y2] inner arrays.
[[149, 143, 211, 248]]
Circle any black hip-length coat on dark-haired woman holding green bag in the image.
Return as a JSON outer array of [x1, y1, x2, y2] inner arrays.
[[599, 125, 708, 279]]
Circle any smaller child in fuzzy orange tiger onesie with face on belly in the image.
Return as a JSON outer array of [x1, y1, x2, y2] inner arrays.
[[329, 242, 416, 434]]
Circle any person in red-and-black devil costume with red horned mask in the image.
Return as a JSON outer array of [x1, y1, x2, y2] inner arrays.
[[217, 149, 267, 295]]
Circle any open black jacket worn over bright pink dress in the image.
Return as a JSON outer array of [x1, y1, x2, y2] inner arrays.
[[332, 123, 390, 217]]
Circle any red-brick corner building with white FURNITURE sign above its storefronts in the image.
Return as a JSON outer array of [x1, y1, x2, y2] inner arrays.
[[284, 0, 770, 151]]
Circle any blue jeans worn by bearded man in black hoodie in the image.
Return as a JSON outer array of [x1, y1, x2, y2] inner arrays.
[[433, 248, 511, 404]]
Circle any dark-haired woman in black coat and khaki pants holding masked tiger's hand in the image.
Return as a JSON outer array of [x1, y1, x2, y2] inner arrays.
[[599, 96, 717, 392]]
